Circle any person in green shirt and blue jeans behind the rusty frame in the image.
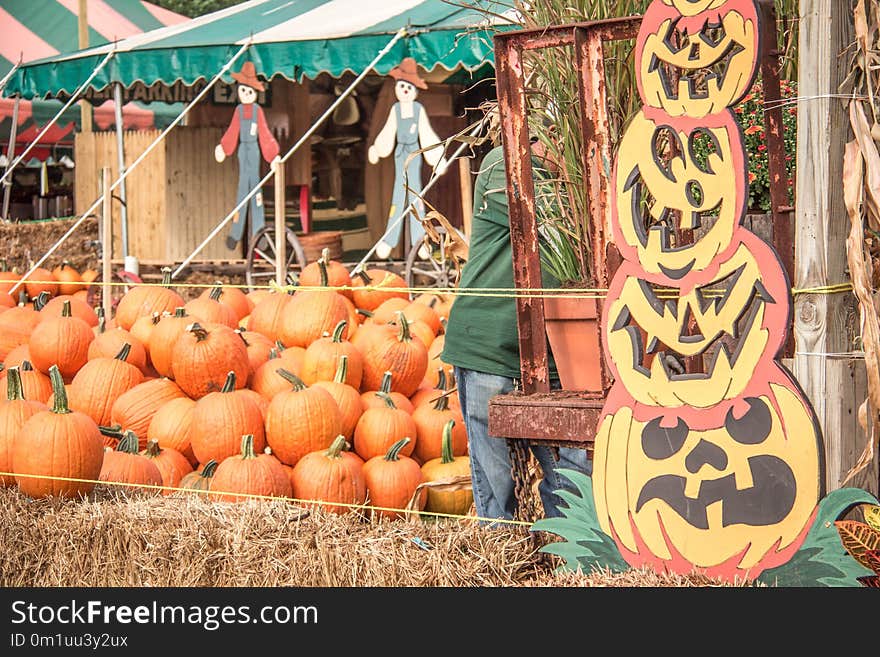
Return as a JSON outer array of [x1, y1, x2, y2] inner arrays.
[[441, 141, 592, 520]]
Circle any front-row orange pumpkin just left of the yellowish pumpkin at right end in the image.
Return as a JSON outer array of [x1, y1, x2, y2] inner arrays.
[[363, 437, 428, 518]]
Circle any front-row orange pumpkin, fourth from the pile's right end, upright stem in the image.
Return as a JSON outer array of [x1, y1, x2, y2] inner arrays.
[[211, 434, 293, 502]]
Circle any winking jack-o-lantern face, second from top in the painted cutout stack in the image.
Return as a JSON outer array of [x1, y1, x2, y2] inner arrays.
[[612, 111, 748, 282]]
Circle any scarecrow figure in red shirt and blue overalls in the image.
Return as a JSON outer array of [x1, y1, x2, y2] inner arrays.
[[214, 62, 279, 249]]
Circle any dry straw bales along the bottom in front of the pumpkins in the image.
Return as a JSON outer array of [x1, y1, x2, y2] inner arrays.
[[0, 489, 744, 587]]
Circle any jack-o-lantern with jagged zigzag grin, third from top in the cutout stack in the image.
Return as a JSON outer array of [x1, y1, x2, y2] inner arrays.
[[602, 230, 790, 408]]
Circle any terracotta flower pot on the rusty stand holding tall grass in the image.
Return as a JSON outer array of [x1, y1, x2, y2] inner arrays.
[[544, 297, 603, 393]]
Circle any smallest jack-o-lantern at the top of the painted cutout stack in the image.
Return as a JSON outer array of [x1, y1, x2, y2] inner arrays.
[[635, 0, 760, 118]]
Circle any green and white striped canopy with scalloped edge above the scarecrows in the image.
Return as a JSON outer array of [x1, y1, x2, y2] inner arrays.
[[4, 0, 519, 101]]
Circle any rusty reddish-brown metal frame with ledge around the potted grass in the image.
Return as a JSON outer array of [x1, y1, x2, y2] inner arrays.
[[489, 5, 794, 449]]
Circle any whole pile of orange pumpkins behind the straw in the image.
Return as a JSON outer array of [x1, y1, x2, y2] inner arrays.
[[0, 251, 473, 517]]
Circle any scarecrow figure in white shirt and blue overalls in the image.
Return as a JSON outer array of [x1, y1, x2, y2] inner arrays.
[[367, 57, 448, 260]]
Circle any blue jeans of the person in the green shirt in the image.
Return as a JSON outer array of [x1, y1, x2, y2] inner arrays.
[[454, 367, 593, 520]]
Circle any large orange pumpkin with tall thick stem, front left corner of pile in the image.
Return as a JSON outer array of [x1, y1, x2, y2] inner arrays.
[[12, 365, 104, 498]]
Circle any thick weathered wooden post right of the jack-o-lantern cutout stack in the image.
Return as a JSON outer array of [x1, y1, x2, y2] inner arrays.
[[794, 0, 876, 492]]
